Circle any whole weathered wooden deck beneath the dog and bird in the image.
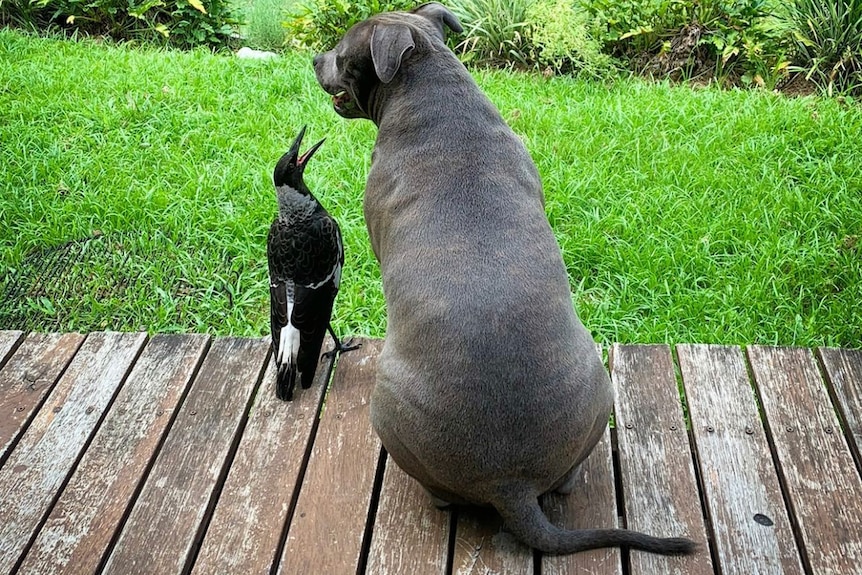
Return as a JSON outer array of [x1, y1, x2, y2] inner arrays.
[[0, 331, 862, 575]]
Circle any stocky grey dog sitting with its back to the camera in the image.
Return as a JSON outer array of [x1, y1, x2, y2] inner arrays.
[[314, 3, 694, 554]]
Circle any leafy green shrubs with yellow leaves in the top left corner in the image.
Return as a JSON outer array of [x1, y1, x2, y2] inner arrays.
[[0, 0, 237, 49]]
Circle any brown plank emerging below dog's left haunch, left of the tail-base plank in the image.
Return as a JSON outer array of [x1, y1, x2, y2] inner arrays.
[[366, 458, 451, 575]]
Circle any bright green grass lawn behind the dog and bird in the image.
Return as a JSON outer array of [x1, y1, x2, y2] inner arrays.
[[0, 31, 862, 347]]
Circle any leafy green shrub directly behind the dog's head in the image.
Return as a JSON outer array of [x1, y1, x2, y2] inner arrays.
[[284, 0, 422, 51]]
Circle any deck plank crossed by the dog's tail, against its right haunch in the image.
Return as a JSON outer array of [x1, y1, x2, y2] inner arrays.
[[542, 429, 622, 575]]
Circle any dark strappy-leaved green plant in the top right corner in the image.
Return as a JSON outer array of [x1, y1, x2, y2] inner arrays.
[[783, 0, 862, 94]]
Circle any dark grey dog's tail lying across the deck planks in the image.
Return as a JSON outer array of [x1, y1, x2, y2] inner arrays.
[[494, 491, 697, 555]]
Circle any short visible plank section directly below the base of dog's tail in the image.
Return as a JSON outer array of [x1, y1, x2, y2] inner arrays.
[[452, 507, 533, 575]]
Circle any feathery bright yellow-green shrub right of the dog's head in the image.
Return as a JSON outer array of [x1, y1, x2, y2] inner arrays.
[[526, 0, 613, 77]]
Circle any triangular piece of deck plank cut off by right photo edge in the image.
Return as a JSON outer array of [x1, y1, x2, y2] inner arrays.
[[818, 348, 862, 466]]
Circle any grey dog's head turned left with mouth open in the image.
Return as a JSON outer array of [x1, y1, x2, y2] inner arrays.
[[314, 2, 462, 119]]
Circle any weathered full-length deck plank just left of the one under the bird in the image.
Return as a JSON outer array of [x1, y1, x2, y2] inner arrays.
[[103, 338, 269, 575]]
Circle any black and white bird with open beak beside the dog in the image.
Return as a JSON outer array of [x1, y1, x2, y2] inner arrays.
[[266, 126, 354, 401]]
